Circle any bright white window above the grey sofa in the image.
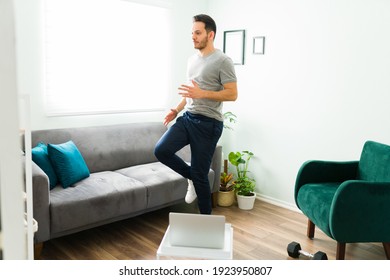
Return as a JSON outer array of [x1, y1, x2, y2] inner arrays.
[[43, 0, 172, 115]]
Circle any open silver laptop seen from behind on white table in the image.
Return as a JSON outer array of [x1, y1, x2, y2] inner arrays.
[[168, 212, 225, 249]]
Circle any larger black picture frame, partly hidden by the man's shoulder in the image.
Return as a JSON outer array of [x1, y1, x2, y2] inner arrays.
[[223, 29, 245, 65]]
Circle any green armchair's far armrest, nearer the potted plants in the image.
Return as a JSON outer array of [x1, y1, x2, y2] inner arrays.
[[294, 160, 359, 205]]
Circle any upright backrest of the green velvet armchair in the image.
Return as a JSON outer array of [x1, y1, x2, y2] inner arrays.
[[358, 141, 390, 182]]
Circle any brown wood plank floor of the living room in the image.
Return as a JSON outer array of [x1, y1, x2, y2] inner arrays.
[[37, 200, 385, 260]]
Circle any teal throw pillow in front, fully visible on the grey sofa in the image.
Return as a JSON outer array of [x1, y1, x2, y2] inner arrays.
[[48, 140, 90, 188]]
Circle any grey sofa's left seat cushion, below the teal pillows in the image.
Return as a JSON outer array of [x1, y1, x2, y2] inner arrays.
[[50, 171, 147, 234]]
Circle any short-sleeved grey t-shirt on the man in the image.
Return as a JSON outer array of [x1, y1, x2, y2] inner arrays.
[[185, 49, 237, 121]]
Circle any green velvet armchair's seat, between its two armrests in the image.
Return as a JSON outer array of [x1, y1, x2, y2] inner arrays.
[[297, 183, 340, 236]]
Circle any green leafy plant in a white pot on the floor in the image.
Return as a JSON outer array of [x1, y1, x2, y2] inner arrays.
[[229, 151, 256, 210]]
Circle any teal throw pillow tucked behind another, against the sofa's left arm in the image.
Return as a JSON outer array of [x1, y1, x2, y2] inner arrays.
[[31, 142, 58, 189]]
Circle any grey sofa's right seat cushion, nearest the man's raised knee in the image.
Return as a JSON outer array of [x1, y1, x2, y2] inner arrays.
[[116, 162, 214, 208]]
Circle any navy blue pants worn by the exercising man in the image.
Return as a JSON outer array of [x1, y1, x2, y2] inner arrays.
[[154, 112, 223, 214]]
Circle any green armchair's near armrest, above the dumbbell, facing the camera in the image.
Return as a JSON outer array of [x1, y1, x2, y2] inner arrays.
[[329, 180, 390, 242]]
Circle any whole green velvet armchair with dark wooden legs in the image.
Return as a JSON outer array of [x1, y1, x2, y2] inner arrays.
[[294, 141, 390, 260]]
